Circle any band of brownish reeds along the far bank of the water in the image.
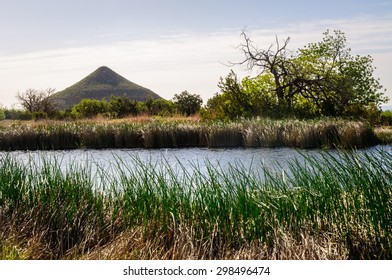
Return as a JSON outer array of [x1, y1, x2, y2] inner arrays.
[[0, 118, 377, 150]]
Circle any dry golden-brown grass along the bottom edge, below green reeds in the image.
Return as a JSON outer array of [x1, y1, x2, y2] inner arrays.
[[0, 226, 352, 260]]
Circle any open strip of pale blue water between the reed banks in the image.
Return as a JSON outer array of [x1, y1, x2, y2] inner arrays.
[[0, 146, 392, 177]]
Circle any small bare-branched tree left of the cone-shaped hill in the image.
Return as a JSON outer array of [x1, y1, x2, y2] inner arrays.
[[16, 88, 56, 115]]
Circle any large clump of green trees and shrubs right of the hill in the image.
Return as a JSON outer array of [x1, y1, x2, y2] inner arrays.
[[208, 31, 388, 120]]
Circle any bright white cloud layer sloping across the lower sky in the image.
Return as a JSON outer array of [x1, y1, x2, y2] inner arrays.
[[0, 16, 392, 108]]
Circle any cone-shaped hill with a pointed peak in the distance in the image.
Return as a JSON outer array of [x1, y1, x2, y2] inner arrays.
[[51, 66, 161, 110]]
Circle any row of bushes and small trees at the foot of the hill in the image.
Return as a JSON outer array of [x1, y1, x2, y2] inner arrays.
[[0, 89, 203, 120]]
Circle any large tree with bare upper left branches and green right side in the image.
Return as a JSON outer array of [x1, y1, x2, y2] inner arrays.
[[233, 31, 387, 116]]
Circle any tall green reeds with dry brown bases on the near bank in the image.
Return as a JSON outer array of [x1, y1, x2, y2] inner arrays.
[[0, 151, 392, 259]]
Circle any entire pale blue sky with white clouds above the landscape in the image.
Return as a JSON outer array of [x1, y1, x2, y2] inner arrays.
[[0, 0, 392, 108]]
